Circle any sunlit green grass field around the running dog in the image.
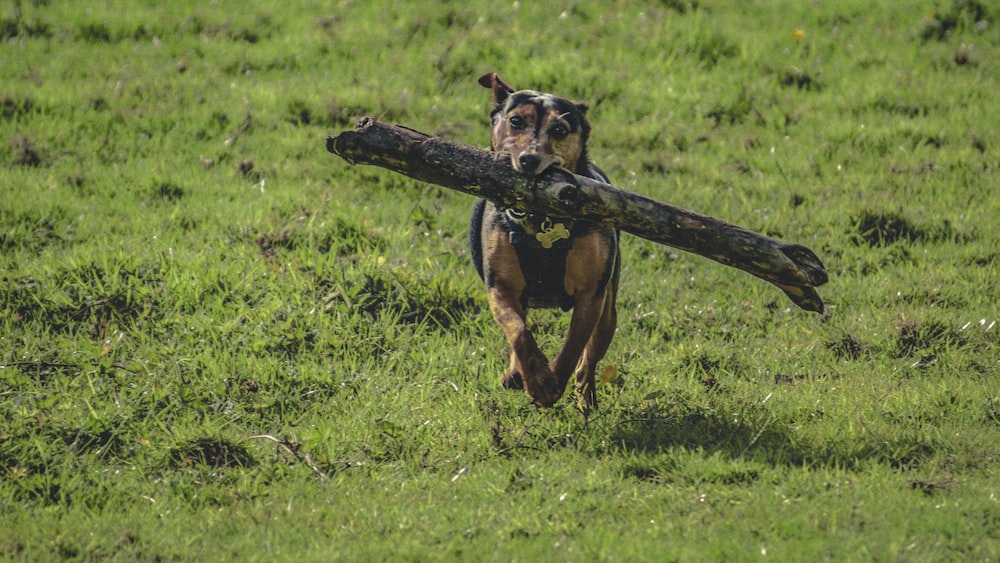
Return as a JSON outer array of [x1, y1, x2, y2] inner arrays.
[[0, 0, 1000, 561]]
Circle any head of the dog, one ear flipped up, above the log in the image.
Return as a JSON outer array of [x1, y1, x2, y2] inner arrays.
[[479, 72, 590, 174]]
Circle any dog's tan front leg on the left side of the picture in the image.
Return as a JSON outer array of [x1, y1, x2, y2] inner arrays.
[[488, 287, 566, 407]]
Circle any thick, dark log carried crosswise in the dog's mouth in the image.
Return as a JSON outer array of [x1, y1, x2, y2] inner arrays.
[[326, 118, 827, 313]]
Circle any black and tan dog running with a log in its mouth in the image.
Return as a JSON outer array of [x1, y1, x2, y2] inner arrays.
[[469, 73, 620, 409]]
